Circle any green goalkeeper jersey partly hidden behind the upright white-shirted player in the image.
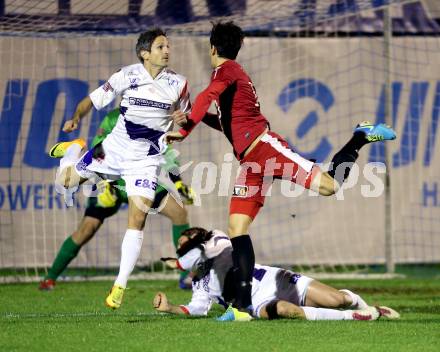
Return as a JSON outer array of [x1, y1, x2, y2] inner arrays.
[[91, 109, 180, 203]]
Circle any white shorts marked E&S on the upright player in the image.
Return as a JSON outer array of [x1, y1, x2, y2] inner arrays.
[[75, 138, 164, 200]]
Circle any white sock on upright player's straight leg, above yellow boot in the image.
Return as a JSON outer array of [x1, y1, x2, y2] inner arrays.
[[115, 229, 144, 288]]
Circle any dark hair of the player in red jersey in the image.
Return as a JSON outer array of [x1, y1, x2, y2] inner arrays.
[[209, 21, 244, 60]]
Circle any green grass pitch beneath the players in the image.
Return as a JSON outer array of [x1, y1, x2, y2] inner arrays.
[[0, 278, 440, 352]]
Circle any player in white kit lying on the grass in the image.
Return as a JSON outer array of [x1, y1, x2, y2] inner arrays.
[[153, 227, 399, 321]]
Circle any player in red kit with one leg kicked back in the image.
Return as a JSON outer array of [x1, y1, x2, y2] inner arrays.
[[165, 22, 396, 321]]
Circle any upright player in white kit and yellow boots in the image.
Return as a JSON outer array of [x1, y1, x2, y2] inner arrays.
[[49, 28, 191, 309]]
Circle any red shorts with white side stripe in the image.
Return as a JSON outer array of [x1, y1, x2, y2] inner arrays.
[[229, 132, 320, 219]]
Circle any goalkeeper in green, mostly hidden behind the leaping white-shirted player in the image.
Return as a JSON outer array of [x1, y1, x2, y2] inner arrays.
[[39, 109, 194, 290]]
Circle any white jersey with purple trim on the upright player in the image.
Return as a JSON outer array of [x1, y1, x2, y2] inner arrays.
[[90, 63, 191, 160]]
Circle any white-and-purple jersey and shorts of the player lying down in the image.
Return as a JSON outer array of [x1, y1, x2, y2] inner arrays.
[[178, 230, 312, 317]]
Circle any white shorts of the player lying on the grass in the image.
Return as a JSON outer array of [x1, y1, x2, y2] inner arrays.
[[252, 265, 313, 317]]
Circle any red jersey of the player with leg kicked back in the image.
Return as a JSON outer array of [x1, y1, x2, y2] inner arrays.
[[179, 60, 269, 159]]
